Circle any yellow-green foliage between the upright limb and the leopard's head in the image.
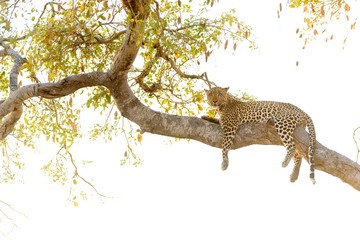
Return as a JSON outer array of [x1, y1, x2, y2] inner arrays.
[[132, 0, 256, 115]]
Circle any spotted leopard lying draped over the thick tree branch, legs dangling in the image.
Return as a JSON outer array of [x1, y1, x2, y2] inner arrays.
[[202, 87, 316, 184]]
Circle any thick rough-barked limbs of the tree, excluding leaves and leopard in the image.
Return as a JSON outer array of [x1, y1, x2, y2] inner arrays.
[[0, 0, 360, 190]]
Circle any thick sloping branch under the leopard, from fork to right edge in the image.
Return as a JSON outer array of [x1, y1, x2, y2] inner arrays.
[[110, 79, 360, 191]]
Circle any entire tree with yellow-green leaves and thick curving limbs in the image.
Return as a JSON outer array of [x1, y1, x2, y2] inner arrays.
[[0, 0, 360, 208]]
